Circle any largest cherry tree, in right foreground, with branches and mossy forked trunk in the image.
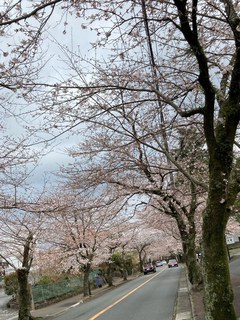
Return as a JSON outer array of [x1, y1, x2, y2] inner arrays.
[[28, 0, 240, 320]]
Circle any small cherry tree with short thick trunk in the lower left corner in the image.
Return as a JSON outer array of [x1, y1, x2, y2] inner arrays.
[[0, 182, 63, 320]]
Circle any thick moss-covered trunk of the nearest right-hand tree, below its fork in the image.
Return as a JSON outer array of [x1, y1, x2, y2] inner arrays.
[[202, 165, 236, 320]]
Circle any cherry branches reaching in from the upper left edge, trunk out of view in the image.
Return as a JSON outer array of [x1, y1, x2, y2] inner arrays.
[[0, 0, 60, 212]]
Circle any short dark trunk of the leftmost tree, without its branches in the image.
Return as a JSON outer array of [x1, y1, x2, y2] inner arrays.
[[17, 268, 33, 320]]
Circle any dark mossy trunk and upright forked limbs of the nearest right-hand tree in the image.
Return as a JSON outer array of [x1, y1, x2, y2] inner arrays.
[[171, 0, 240, 320]]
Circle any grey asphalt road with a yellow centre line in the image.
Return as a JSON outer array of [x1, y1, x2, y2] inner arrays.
[[52, 267, 181, 320]]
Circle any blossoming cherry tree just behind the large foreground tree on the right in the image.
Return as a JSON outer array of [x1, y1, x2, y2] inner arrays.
[[22, 0, 207, 290]]
